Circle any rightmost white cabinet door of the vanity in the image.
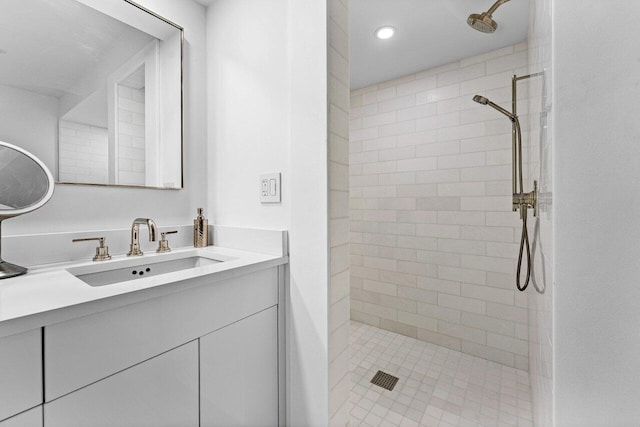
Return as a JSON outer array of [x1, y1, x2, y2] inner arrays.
[[200, 307, 278, 427]]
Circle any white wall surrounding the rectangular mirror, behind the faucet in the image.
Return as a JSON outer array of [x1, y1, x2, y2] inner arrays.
[[1, 0, 207, 236]]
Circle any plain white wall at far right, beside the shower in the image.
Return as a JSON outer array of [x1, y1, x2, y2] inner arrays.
[[553, 0, 640, 427]]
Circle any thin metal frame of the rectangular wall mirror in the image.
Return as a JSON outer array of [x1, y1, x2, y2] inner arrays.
[[55, 0, 184, 191]]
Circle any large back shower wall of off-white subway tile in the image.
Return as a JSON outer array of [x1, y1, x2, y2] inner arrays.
[[349, 43, 528, 370]]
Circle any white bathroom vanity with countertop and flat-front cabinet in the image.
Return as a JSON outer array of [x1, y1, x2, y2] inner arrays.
[[0, 237, 287, 427]]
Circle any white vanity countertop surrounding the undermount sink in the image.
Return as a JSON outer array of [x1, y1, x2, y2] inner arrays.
[[0, 246, 288, 337]]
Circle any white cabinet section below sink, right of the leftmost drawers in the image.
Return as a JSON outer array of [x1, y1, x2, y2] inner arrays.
[[38, 267, 283, 427]]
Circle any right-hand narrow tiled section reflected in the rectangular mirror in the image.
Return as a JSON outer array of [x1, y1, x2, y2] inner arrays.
[[118, 85, 146, 185]]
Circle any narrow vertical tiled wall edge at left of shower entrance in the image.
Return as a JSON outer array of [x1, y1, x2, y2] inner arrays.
[[328, 0, 351, 427]]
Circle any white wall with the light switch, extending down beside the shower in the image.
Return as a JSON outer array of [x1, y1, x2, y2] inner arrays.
[[207, 0, 329, 426]]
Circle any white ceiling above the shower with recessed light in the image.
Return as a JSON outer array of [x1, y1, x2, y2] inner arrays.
[[349, 0, 529, 89]]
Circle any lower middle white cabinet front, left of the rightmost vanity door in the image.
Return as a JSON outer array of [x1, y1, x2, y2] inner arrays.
[[44, 341, 198, 427]]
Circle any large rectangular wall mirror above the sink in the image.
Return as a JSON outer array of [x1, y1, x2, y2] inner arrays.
[[0, 0, 184, 189]]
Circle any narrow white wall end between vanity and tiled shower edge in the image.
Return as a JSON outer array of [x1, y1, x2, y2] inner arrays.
[[287, 0, 330, 426]]
